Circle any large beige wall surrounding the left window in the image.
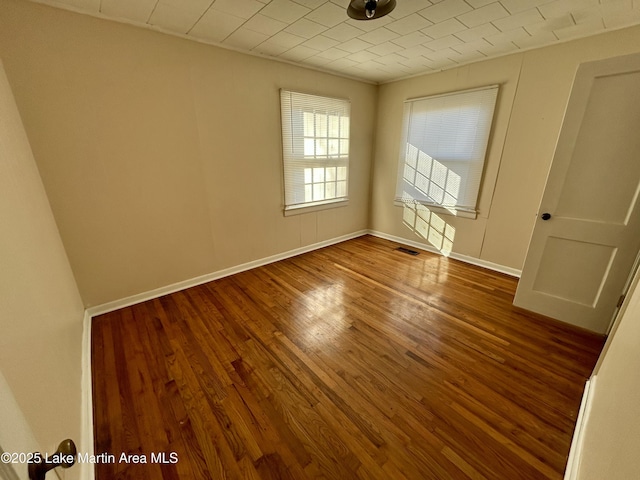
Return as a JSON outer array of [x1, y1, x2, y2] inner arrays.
[[0, 0, 377, 306]]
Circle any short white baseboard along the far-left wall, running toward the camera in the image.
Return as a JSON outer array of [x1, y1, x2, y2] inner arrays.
[[78, 310, 95, 480]]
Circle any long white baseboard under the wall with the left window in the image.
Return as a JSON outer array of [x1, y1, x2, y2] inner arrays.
[[87, 230, 368, 317]]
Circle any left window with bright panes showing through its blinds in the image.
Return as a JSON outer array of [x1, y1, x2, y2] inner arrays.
[[280, 90, 350, 214]]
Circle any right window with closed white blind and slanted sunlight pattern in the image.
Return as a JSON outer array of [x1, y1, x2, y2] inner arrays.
[[395, 85, 498, 218]]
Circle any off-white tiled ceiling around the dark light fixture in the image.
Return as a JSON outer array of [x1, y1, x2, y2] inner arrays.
[[28, 0, 640, 81]]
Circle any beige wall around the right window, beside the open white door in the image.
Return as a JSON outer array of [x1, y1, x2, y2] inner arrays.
[[371, 27, 640, 269]]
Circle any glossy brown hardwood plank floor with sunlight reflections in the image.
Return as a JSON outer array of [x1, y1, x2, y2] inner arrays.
[[92, 236, 603, 480]]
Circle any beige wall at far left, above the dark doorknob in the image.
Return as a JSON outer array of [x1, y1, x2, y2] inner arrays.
[[0, 61, 84, 478]]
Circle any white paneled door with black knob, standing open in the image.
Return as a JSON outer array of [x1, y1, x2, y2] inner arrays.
[[514, 50, 640, 333]]
